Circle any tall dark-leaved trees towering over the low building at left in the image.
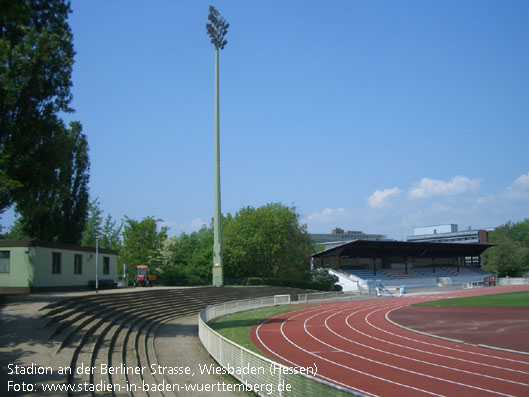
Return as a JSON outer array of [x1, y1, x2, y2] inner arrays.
[[0, 0, 88, 237]]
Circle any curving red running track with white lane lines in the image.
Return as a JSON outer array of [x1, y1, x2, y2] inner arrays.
[[251, 286, 529, 397]]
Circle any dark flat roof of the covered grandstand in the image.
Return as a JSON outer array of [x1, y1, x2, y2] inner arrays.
[[312, 240, 494, 258]]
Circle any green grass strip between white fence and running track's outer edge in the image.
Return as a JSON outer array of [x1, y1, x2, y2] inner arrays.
[[208, 305, 307, 353]]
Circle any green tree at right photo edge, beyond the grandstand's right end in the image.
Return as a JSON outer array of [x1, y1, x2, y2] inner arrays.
[[485, 219, 529, 277]]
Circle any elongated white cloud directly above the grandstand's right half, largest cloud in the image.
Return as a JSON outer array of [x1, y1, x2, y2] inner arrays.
[[408, 175, 481, 199]]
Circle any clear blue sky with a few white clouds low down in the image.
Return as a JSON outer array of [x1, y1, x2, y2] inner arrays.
[[2, 0, 529, 240]]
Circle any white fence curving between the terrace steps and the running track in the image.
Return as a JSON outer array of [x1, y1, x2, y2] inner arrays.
[[198, 295, 363, 397]]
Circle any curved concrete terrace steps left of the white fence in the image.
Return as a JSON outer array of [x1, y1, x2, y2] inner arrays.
[[41, 287, 306, 396]]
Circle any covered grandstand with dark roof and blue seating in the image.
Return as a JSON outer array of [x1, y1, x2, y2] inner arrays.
[[313, 240, 492, 287]]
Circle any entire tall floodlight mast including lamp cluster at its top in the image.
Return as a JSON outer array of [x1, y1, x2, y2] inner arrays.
[[206, 6, 230, 287]]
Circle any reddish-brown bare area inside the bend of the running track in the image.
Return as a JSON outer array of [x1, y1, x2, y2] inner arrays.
[[389, 306, 529, 353]]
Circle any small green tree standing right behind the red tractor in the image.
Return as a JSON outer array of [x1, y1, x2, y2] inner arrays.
[[120, 216, 167, 281]]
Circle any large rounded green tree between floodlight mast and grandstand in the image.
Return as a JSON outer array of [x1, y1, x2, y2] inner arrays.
[[223, 203, 314, 280]]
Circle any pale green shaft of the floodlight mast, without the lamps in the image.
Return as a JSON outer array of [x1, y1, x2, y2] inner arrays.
[[213, 48, 224, 287]]
